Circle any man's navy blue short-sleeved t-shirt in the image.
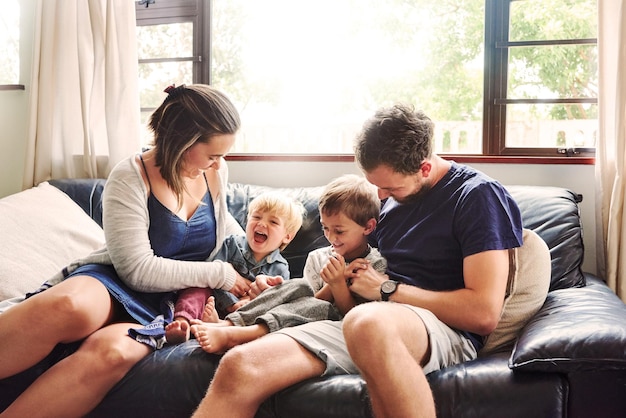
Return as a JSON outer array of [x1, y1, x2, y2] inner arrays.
[[370, 162, 522, 290]]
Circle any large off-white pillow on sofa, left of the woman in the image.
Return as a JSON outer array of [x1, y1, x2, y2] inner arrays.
[[0, 182, 104, 300]]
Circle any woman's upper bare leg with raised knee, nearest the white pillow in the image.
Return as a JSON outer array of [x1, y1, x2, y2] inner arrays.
[[0, 277, 114, 378]]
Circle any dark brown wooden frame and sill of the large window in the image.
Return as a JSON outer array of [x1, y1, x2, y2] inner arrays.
[[136, 0, 597, 164]]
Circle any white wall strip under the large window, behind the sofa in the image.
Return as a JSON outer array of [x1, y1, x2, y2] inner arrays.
[[228, 161, 596, 273]]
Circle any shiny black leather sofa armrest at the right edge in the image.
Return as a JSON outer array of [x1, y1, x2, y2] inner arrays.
[[509, 274, 626, 373]]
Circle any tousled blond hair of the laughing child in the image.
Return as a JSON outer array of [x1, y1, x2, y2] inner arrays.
[[248, 192, 306, 251]]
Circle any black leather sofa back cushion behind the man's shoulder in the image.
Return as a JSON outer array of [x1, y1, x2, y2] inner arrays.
[[506, 185, 585, 290]]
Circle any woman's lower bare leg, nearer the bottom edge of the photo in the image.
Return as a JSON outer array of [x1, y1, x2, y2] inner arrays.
[[0, 323, 152, 418]]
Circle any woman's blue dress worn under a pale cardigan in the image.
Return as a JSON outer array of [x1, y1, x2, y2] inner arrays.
[[68, 160, 217, 325]]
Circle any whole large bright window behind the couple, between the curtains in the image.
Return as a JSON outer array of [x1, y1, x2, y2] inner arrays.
[[137, 0, 597, 158]]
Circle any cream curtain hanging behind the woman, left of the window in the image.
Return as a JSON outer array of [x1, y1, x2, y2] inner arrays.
[[23, 0, 140, 188]]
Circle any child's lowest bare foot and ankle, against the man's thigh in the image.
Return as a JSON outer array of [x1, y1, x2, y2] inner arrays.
[[191, 322, 270, 354]]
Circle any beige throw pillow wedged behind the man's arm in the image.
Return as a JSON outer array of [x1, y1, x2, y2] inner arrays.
[[479, 229, 552, 355]]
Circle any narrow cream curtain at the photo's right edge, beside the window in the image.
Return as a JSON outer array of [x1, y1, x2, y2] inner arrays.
[[596, 0, 626, 301]]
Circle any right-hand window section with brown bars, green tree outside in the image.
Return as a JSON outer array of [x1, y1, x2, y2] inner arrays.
[[484, 0, 598, 156]]
